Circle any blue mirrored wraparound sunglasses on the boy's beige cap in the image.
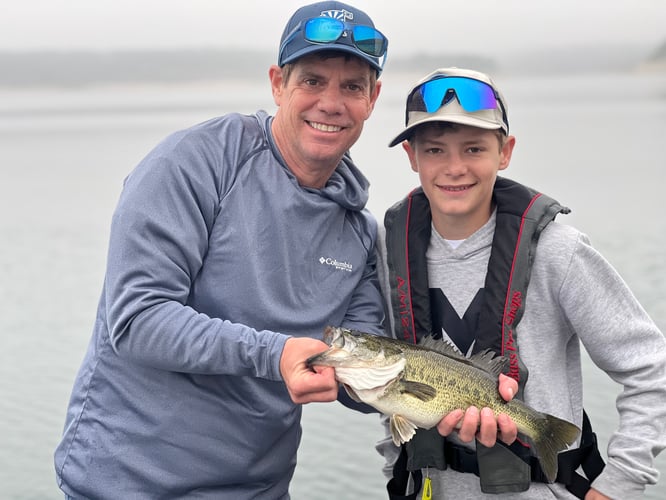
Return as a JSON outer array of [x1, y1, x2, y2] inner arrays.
[[407, 76, 509, 129]]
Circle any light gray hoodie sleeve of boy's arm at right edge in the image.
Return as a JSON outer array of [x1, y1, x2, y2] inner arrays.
[[561, 235, 666, 498]]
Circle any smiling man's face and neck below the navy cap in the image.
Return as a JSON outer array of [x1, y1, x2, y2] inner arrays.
[[270, 55, 380, 187]]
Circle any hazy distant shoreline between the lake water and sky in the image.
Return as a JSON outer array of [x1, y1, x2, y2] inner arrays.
[[0, 43, 666, 87]]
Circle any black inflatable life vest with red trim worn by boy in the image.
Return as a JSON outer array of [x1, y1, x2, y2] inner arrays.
[[384, 177, 604, 499]]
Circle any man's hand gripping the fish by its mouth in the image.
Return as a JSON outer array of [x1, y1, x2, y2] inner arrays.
[[280, 337, 338, 404]]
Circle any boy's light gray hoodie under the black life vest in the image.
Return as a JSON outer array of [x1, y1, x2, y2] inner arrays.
[[377, 209, 666, 500]]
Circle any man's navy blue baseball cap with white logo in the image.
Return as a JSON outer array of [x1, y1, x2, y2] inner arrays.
[[278, 1, 388, 74]]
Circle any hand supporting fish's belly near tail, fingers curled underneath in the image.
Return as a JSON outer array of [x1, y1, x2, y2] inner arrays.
[[437, 374, 518, 447]]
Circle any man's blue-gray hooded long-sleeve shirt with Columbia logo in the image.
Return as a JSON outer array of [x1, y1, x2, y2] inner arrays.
[[55, 112, 383, 500]]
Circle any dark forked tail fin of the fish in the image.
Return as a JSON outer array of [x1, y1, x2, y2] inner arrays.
[[530, 415, 580, 483]]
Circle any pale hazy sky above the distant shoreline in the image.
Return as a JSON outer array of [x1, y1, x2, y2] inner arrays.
[[0, 0, 666, 55]]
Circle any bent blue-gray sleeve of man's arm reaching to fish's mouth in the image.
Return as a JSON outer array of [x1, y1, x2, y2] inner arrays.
[[104, 124, 287, 380]]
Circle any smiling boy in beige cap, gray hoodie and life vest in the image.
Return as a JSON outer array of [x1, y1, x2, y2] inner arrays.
[[377, 68, 666, 500]]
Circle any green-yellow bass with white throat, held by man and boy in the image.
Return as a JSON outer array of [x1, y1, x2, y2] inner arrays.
[[306, 326, 580, 482]]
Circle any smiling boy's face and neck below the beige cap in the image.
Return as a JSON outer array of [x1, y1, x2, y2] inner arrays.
[[403, 124, 515, 240]]
